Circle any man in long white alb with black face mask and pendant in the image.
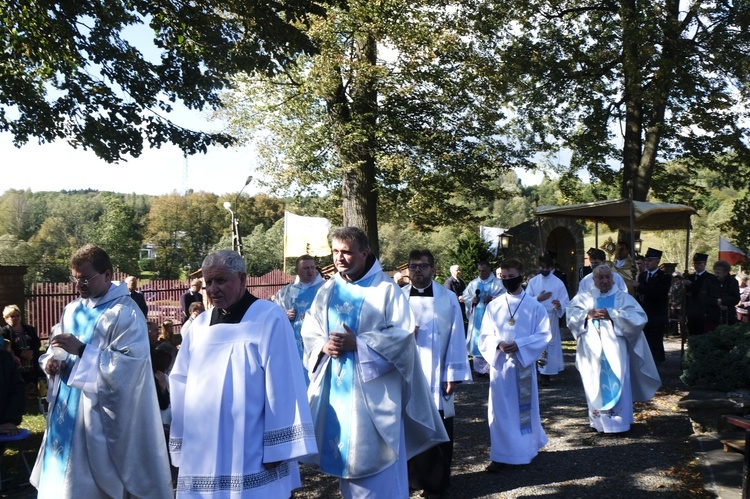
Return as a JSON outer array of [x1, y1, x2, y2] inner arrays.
[[479, 259, 552, 473]]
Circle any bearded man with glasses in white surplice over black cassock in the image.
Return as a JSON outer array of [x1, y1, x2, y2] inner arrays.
[[403, 249, 471, 497]]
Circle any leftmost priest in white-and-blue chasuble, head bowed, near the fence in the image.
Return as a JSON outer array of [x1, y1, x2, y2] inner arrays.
[[30, 244, 172, 499]]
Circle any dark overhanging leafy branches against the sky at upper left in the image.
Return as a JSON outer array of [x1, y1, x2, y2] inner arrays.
[[0, 0, 334, 162]]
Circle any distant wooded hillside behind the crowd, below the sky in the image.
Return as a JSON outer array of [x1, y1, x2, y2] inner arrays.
[[0, 162, 750, 288]]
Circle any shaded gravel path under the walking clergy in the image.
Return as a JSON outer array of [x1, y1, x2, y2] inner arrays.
[[295, 338, 713, 499]]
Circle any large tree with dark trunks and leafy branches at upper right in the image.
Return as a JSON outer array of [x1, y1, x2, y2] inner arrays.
[[463, 0, 750, 200]]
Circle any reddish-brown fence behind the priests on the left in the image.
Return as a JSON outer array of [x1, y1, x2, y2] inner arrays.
[[26, 274, 293, 338]]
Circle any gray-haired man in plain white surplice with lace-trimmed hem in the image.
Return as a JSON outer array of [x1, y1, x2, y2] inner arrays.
[[169, 250, 317, 498]]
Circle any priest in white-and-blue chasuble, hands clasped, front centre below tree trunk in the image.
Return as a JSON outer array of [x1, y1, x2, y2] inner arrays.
[[302, 227, 448, 499]]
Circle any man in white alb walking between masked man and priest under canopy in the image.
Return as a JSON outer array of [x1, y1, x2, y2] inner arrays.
[[526, 255, 568, 385]]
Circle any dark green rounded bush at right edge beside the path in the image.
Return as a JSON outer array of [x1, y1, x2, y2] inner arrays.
[[680, 324, 750, 391]]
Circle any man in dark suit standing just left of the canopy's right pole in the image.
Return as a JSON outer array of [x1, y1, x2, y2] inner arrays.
[[636, 248, 672, 362]]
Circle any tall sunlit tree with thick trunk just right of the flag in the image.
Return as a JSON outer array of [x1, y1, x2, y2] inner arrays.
[[223, 0, 528, 253]]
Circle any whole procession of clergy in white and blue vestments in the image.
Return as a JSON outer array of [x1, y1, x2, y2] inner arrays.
[[32, 232, 663, 499]]
